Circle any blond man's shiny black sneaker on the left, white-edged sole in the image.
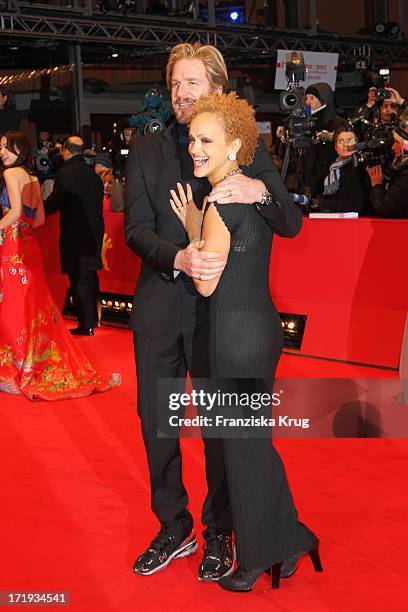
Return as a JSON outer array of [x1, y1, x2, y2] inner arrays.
[[133, 529, 198, 576]]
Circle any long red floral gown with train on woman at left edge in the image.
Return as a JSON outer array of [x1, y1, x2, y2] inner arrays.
[[0, 183, 121, 400]]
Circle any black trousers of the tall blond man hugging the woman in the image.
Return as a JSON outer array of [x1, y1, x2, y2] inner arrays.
[[134, 293, 232, 535]]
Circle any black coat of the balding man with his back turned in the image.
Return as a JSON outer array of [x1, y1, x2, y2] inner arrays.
[[44, 155, 104, 273]]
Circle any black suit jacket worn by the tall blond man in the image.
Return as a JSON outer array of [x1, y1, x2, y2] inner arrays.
[[125, 124, 302, 337]]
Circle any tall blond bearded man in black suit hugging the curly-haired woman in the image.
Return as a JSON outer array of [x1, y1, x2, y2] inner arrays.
[[125, 44, 301, 581]]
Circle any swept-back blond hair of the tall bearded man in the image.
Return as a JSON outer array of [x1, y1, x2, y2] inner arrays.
[[166, 43, 228, 93]]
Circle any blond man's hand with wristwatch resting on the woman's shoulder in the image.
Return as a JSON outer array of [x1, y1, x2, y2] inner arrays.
[[208, 174, 266, 204]]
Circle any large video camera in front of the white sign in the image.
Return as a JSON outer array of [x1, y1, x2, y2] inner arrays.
[[279, 51, 315, 149]]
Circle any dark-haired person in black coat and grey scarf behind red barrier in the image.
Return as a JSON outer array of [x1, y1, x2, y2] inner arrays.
[[319, 128, 366, 213]]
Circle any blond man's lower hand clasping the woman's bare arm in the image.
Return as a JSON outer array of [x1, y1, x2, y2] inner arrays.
[[174, 240, 227, 280]]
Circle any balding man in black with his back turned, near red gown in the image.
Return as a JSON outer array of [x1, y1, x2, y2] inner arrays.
[[44, 136, 104, 336]]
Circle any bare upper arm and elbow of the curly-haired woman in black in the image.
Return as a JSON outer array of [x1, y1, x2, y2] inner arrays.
[[194, 204, 231, 297]]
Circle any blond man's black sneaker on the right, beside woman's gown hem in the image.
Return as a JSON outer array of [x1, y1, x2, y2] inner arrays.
[[198, 533, 234, 582]]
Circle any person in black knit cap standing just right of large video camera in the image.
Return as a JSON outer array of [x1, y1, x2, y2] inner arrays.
[[302, 83, 345, 197]]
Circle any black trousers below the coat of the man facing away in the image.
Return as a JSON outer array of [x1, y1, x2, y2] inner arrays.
[[68, 270, 99, 329]]
